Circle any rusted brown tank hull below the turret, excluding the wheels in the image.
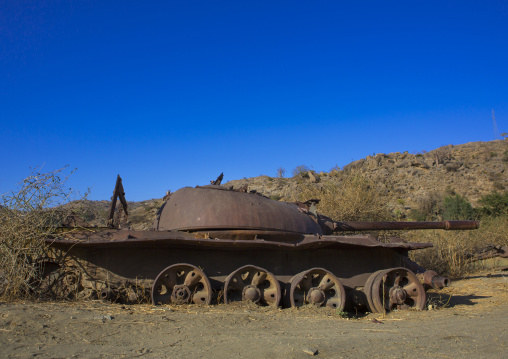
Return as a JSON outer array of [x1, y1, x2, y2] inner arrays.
[[47, 229, 430, 307]]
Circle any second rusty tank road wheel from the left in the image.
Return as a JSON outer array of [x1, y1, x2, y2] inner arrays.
[[224, 265, 281, 307]]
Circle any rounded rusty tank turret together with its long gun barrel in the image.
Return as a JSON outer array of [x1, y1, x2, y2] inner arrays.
[[154, 185, 479, 241]]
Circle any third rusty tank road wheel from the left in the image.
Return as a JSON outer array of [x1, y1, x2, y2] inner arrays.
[[289, 268, 346, 311]]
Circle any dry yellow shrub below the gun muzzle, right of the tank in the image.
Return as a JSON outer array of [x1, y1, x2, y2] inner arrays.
[[405, 215, 508, 277]]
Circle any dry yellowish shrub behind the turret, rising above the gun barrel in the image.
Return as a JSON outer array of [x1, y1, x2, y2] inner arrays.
[[286, 171, 389, 221]]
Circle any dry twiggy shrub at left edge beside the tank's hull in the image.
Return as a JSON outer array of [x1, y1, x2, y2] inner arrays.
[[0, 167, 82, 299]]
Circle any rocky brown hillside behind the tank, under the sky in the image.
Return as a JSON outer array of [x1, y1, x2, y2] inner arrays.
[[79, 140, 508, 229]]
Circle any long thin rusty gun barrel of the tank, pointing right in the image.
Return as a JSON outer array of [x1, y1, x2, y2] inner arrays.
[[333, 221, 480, 232]]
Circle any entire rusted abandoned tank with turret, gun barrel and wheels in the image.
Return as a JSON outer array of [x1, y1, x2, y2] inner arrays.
[[41, 176, 479, 312]]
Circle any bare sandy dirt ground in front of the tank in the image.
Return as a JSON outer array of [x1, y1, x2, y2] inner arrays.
[[0, 271, 508, 358]]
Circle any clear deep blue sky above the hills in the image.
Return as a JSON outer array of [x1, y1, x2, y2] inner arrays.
[[0, 0, 508, 201]]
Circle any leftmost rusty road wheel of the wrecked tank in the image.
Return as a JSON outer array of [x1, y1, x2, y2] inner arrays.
[[152, 263, 212, 305]]
